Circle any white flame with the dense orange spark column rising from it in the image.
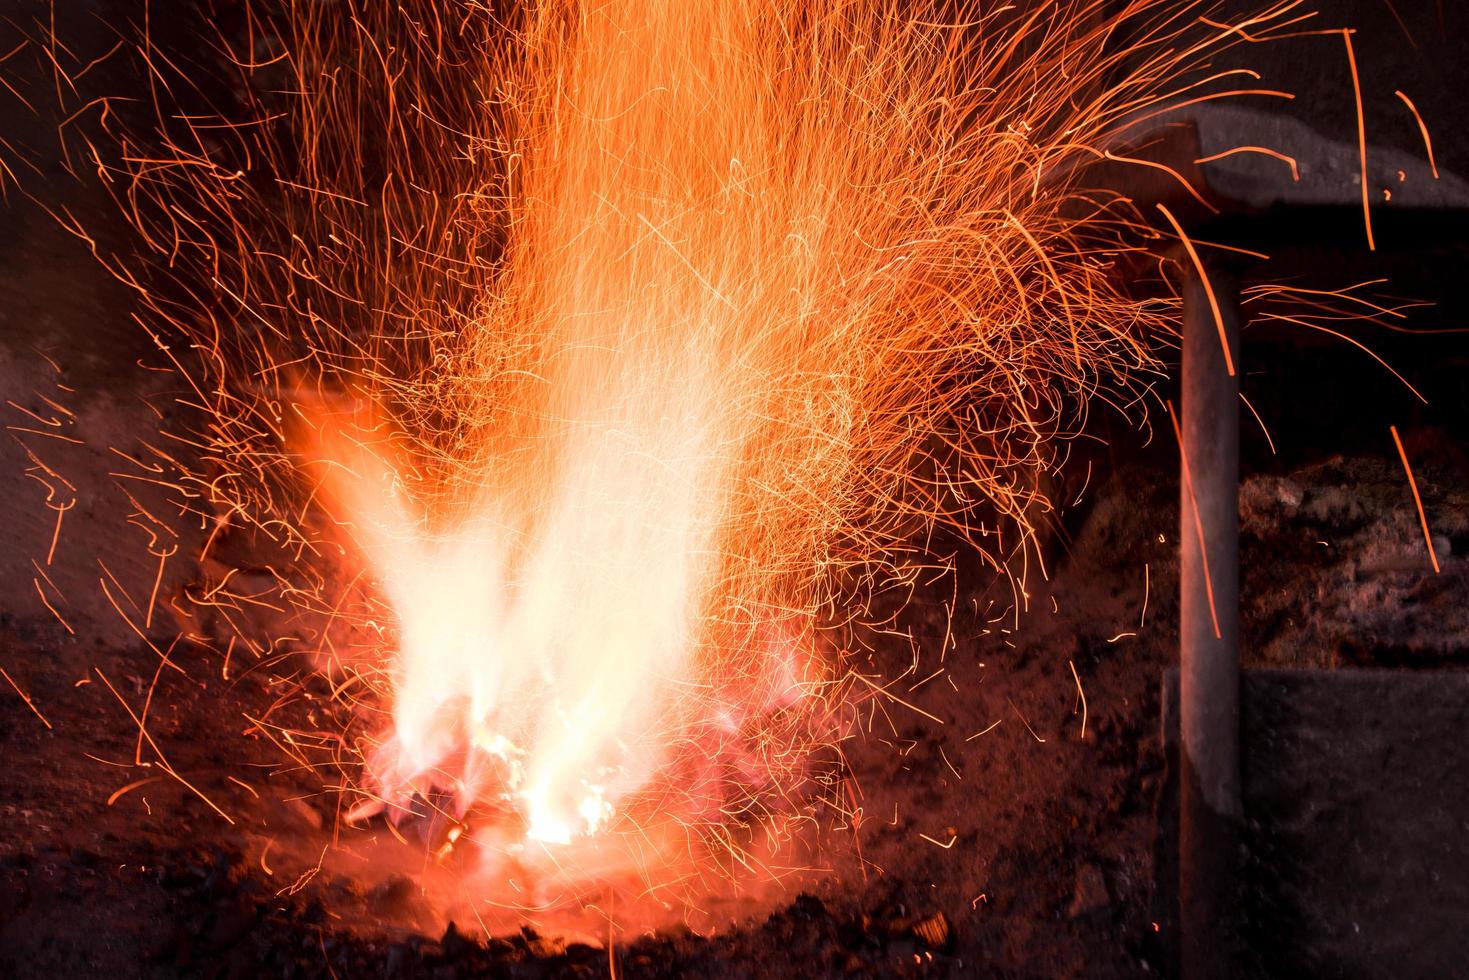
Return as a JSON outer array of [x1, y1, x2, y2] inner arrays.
[[309, 0, 1169, 843]]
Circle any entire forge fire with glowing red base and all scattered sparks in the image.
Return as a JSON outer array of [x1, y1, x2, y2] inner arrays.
[[0, 0, 1469, 976]]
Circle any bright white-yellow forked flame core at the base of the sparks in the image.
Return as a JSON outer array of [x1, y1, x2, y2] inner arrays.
[[312, 387, 806, 843]]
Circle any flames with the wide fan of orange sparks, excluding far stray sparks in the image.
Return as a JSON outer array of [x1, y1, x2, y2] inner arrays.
[[5, 0, 1374, 922]]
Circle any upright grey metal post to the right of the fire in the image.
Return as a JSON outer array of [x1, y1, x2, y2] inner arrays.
[[1178, 263, 1241, 980]]
